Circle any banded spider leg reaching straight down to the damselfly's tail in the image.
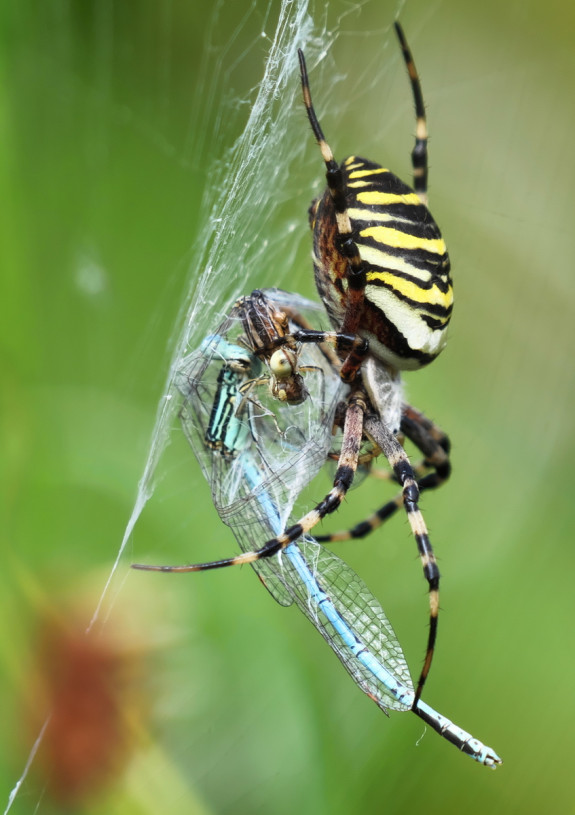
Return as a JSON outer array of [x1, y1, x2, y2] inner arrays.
[[364, 416, 439, 705]]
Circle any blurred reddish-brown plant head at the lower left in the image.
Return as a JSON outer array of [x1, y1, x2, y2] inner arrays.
[[26, 619, 145, 808]]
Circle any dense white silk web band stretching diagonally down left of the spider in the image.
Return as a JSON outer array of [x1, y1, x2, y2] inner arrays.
[[90, 0, 410, 627]]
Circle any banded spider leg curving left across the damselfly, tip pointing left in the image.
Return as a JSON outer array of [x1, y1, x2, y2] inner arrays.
[[132, 390, 367, 572]]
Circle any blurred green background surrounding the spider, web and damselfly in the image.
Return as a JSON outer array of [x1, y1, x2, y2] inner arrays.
[[0, 0, 575, 815]]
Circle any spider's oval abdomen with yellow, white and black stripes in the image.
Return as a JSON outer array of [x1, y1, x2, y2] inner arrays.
[[313, 156, 453, 369]]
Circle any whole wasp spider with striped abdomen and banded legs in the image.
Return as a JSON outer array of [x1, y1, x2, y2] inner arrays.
[[136, 23, 453, 705]]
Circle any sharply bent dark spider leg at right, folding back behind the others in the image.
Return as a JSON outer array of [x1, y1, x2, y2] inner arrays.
[[315, 405, 451, 543]]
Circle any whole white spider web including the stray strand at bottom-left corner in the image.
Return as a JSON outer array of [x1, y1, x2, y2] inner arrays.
[[4, 0, 412, 813]]
